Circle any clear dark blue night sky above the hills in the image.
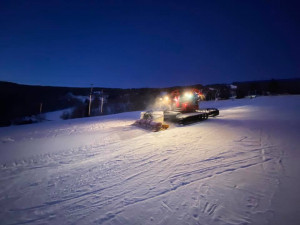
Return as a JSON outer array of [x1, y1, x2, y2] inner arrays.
[[0, 0, 300, 88]]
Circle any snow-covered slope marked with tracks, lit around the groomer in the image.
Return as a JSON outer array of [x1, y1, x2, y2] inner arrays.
[[0, 96, 300, 225]]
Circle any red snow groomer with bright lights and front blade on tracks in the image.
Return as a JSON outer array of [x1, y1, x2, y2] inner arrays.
[[134, 89, 219, 131]]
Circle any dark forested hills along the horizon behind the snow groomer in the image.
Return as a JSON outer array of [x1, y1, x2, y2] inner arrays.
[[0, 79, 300, 126]]
